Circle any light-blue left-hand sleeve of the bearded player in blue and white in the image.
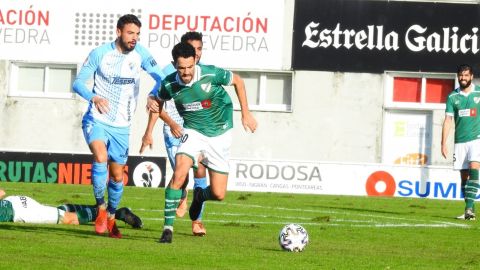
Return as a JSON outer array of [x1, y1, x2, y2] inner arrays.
[[72, 49, 101, 101]]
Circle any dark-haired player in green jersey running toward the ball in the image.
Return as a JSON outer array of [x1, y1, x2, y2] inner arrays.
[[142, 42, 257, 243]]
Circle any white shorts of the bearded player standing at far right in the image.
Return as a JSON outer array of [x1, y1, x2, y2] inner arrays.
[[453, 139, 480, 170]]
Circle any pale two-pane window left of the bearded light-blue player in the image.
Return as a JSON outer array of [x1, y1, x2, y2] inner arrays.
[[9, 62, 77, 98]]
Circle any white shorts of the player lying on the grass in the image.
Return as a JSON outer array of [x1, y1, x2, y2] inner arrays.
[[5, 196, 65, 224]]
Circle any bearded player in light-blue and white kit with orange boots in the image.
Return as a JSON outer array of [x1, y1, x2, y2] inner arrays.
[[73, 14, 164, 238]]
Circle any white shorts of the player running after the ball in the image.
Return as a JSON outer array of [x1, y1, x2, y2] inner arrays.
[[177, 128, 232, 174]]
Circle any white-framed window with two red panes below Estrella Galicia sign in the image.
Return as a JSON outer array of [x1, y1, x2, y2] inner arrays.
[[385, 73, 456, 110]]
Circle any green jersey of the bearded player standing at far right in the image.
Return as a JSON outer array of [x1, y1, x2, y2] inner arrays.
[[445, 85, 480, 143]]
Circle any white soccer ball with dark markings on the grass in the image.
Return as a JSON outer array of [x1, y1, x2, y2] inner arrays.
[[278, 224, 308, 252]]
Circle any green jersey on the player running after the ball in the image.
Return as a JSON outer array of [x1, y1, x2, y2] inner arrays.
[[157, 64, 233, 137]]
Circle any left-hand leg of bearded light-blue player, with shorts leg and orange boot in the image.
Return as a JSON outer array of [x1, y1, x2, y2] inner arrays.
[[82, 120, 108, 234]]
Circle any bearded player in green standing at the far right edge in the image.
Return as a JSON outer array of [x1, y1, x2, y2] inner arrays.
[[442, 65, 480, 220]]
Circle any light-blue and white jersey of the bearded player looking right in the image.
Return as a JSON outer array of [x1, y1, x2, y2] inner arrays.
[[73, 41, 165, 127]]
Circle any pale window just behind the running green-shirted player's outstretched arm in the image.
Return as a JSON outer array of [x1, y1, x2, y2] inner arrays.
[[226, 70, 293, 112]]
